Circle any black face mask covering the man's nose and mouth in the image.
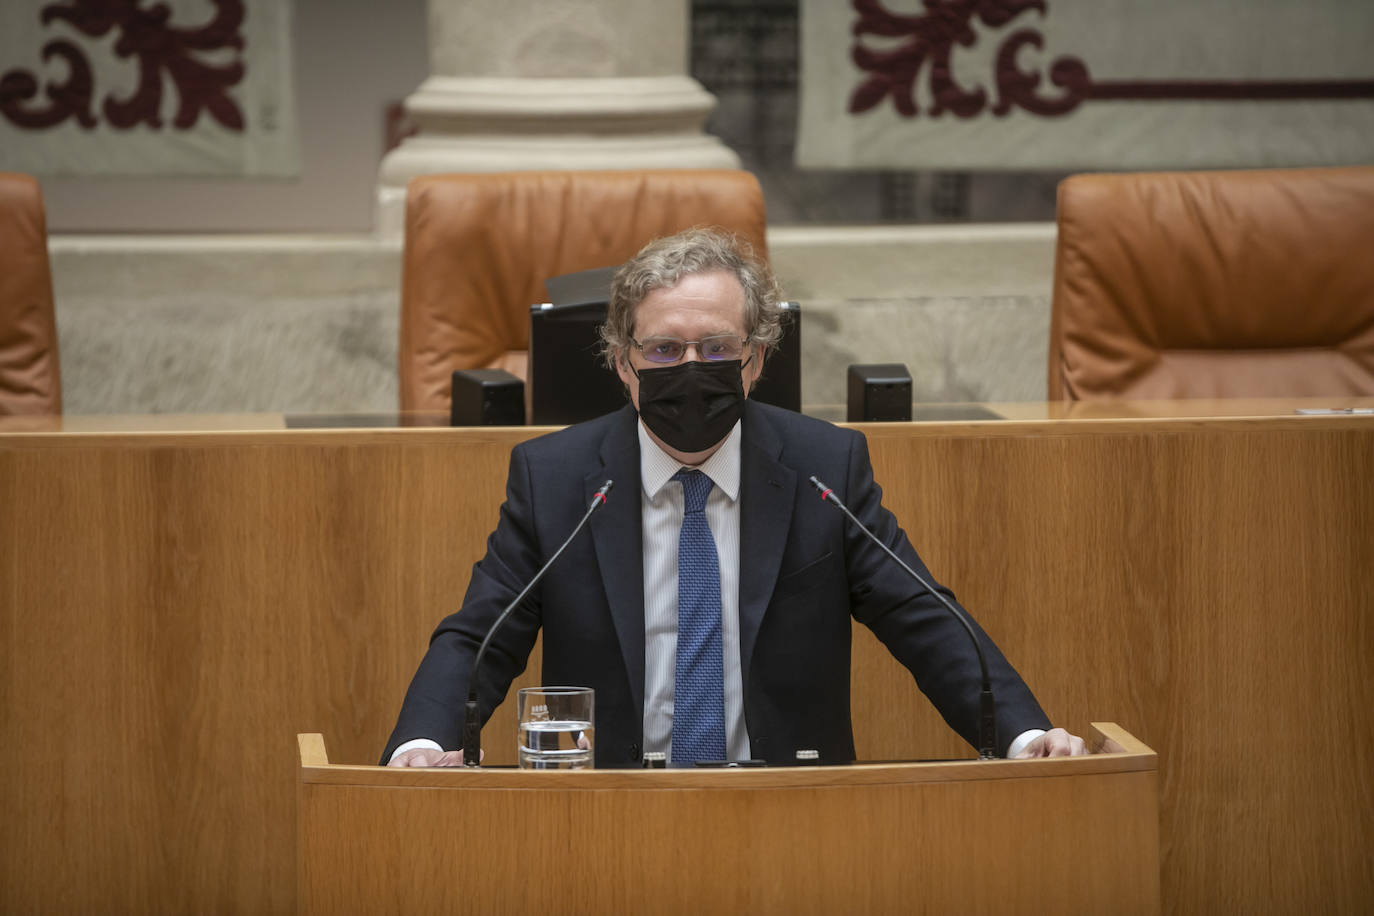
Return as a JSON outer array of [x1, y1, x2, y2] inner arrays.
[[635, 360, 745, 452]]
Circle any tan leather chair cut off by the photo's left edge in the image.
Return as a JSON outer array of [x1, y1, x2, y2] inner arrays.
[[0, 172, 62, 416]]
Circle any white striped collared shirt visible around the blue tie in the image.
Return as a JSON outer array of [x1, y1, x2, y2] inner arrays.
[[639, 423, 749, 759]]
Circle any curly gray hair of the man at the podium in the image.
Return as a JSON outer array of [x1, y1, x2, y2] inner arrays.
[[600, 229, 782, 368]]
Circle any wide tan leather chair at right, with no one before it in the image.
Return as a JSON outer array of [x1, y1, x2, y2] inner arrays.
[[1050, 166, 1374, 400]]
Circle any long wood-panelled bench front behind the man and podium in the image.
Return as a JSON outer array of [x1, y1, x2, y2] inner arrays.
[[0, 417, 1374, 913]]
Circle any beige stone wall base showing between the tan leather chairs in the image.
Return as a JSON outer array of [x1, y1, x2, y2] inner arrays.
[[51, 225, 1054, 416]]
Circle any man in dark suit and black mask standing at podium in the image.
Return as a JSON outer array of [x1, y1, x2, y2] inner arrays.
[[382, 231, 1083, 766]]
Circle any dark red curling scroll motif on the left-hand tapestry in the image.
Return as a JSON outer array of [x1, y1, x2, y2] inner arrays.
[[0, 0, 245, 132]]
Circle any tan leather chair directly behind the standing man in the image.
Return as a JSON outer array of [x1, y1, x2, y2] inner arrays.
[[398, 169, 768, 411]]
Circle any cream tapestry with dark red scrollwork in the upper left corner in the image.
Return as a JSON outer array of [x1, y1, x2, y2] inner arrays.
[[0, 0, 300, 176]]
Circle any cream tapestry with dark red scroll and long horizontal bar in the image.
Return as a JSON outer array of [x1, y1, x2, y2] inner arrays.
[[797, 0, 1374, 169]]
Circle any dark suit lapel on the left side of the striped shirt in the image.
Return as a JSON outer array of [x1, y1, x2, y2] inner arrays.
[[583, 407, 644, 709]]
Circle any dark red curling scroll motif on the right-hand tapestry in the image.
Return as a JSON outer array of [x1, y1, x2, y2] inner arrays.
[[849, 0, 1087, 118]]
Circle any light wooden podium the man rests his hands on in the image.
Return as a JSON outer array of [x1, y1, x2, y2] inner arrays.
[[297, 722, 1160, 915]]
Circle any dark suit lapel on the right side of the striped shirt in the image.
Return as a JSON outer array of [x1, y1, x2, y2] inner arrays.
[[739, 401, 797, 691]]
